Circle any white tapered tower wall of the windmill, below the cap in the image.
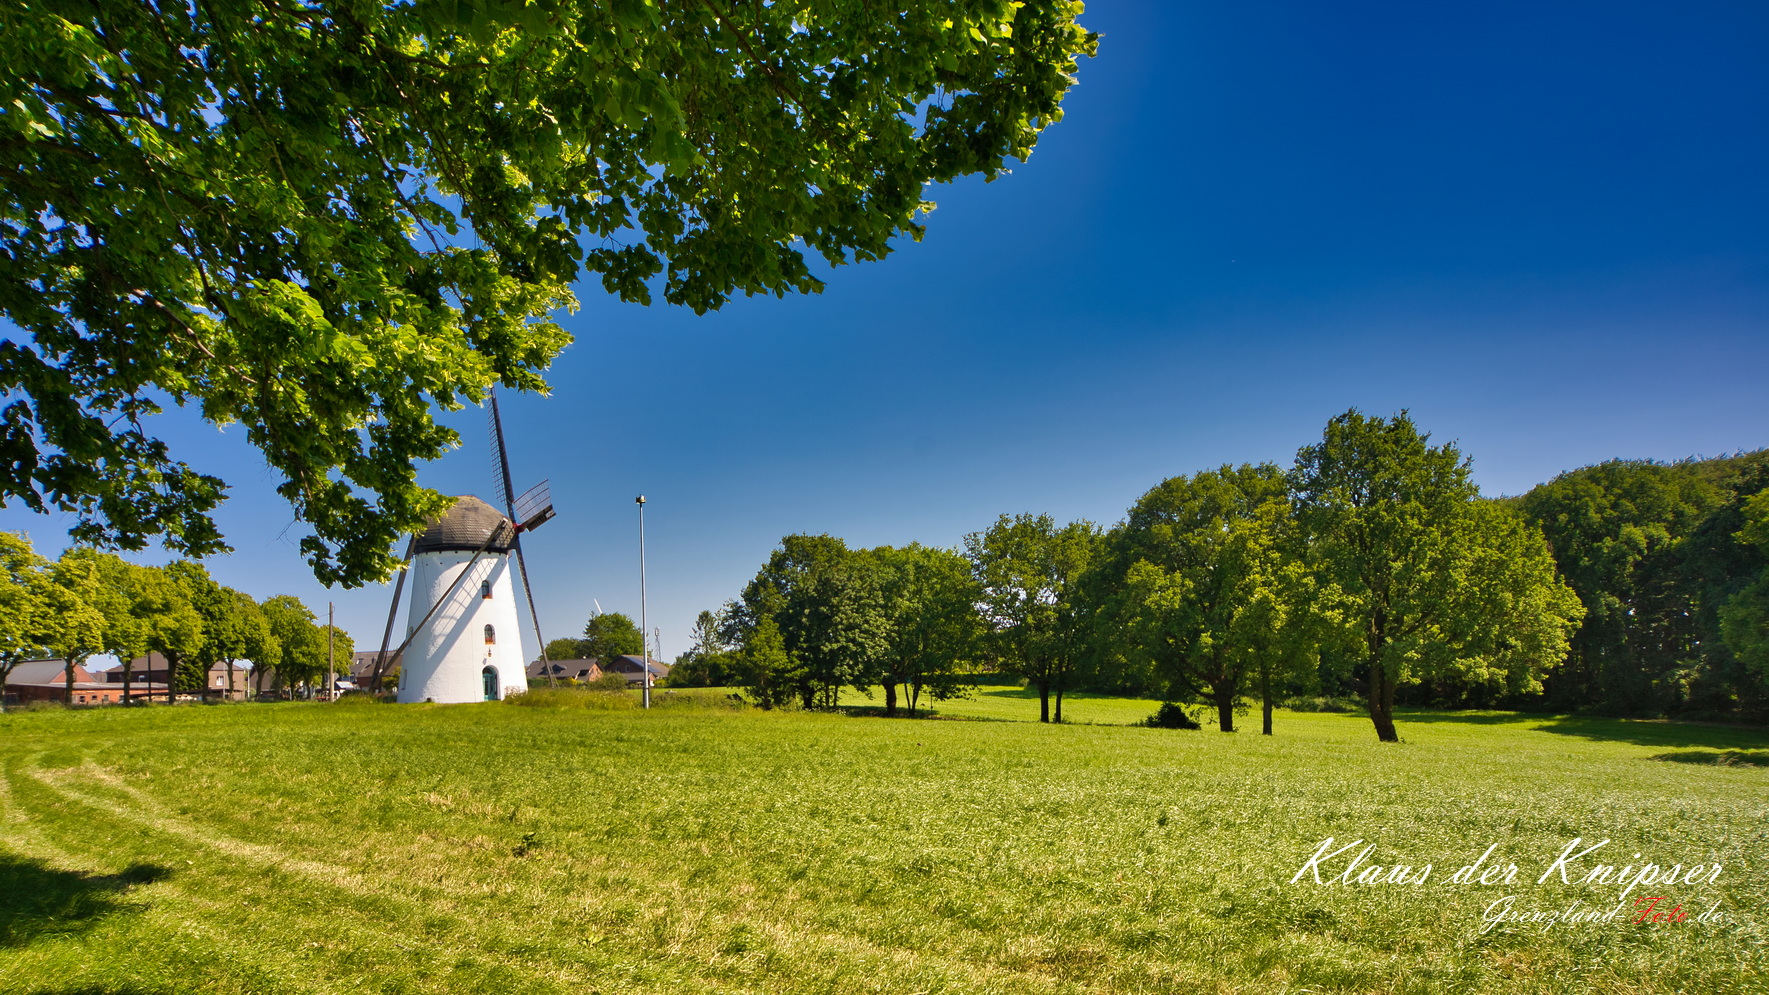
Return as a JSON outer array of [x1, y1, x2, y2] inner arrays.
[[400, 551, 527, 703]]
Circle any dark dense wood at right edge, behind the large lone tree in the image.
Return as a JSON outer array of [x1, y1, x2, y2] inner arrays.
[[1514, 450, 1769, 721]]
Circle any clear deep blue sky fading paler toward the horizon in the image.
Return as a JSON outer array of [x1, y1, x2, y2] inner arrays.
[[0, 2, 1769, 657]]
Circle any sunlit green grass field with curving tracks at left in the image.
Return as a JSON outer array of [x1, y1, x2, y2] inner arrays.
[[0, 689, 1769, 995]]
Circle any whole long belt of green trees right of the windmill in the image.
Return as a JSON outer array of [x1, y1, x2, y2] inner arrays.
[[672, 403, 1769, 740]]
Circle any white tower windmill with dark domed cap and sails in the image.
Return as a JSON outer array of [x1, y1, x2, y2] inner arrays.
[[375, 390, 554, 703]]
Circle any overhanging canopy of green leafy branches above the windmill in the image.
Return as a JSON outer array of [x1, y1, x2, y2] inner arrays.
[[0, 0, 1097, 584]]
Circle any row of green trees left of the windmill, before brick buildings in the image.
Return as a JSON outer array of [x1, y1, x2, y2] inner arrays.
[[0, 533, 352, 701]]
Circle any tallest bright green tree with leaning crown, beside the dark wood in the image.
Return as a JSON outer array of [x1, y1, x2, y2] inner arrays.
[[1290, 411, 1583, 742]]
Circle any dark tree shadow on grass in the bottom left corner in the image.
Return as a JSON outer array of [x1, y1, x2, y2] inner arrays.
[[0, 853, 172, 947]]
